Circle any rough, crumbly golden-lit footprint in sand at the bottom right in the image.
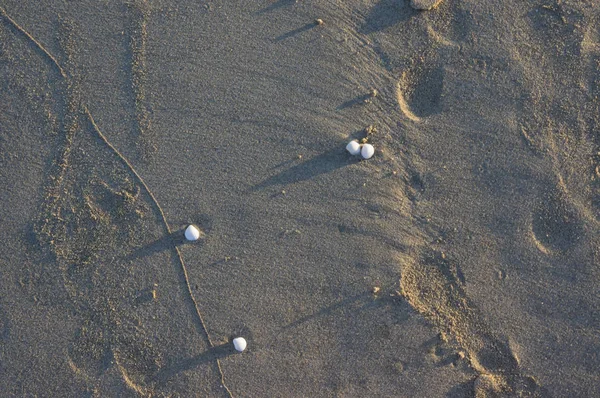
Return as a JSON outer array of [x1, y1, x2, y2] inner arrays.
[[400, 249, 538, 396]]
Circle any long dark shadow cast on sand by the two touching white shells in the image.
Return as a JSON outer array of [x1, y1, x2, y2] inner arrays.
[[252, 148, 352, 191]]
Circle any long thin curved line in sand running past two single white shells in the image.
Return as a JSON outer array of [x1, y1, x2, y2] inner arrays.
[[0, 6, 233, 397]]
